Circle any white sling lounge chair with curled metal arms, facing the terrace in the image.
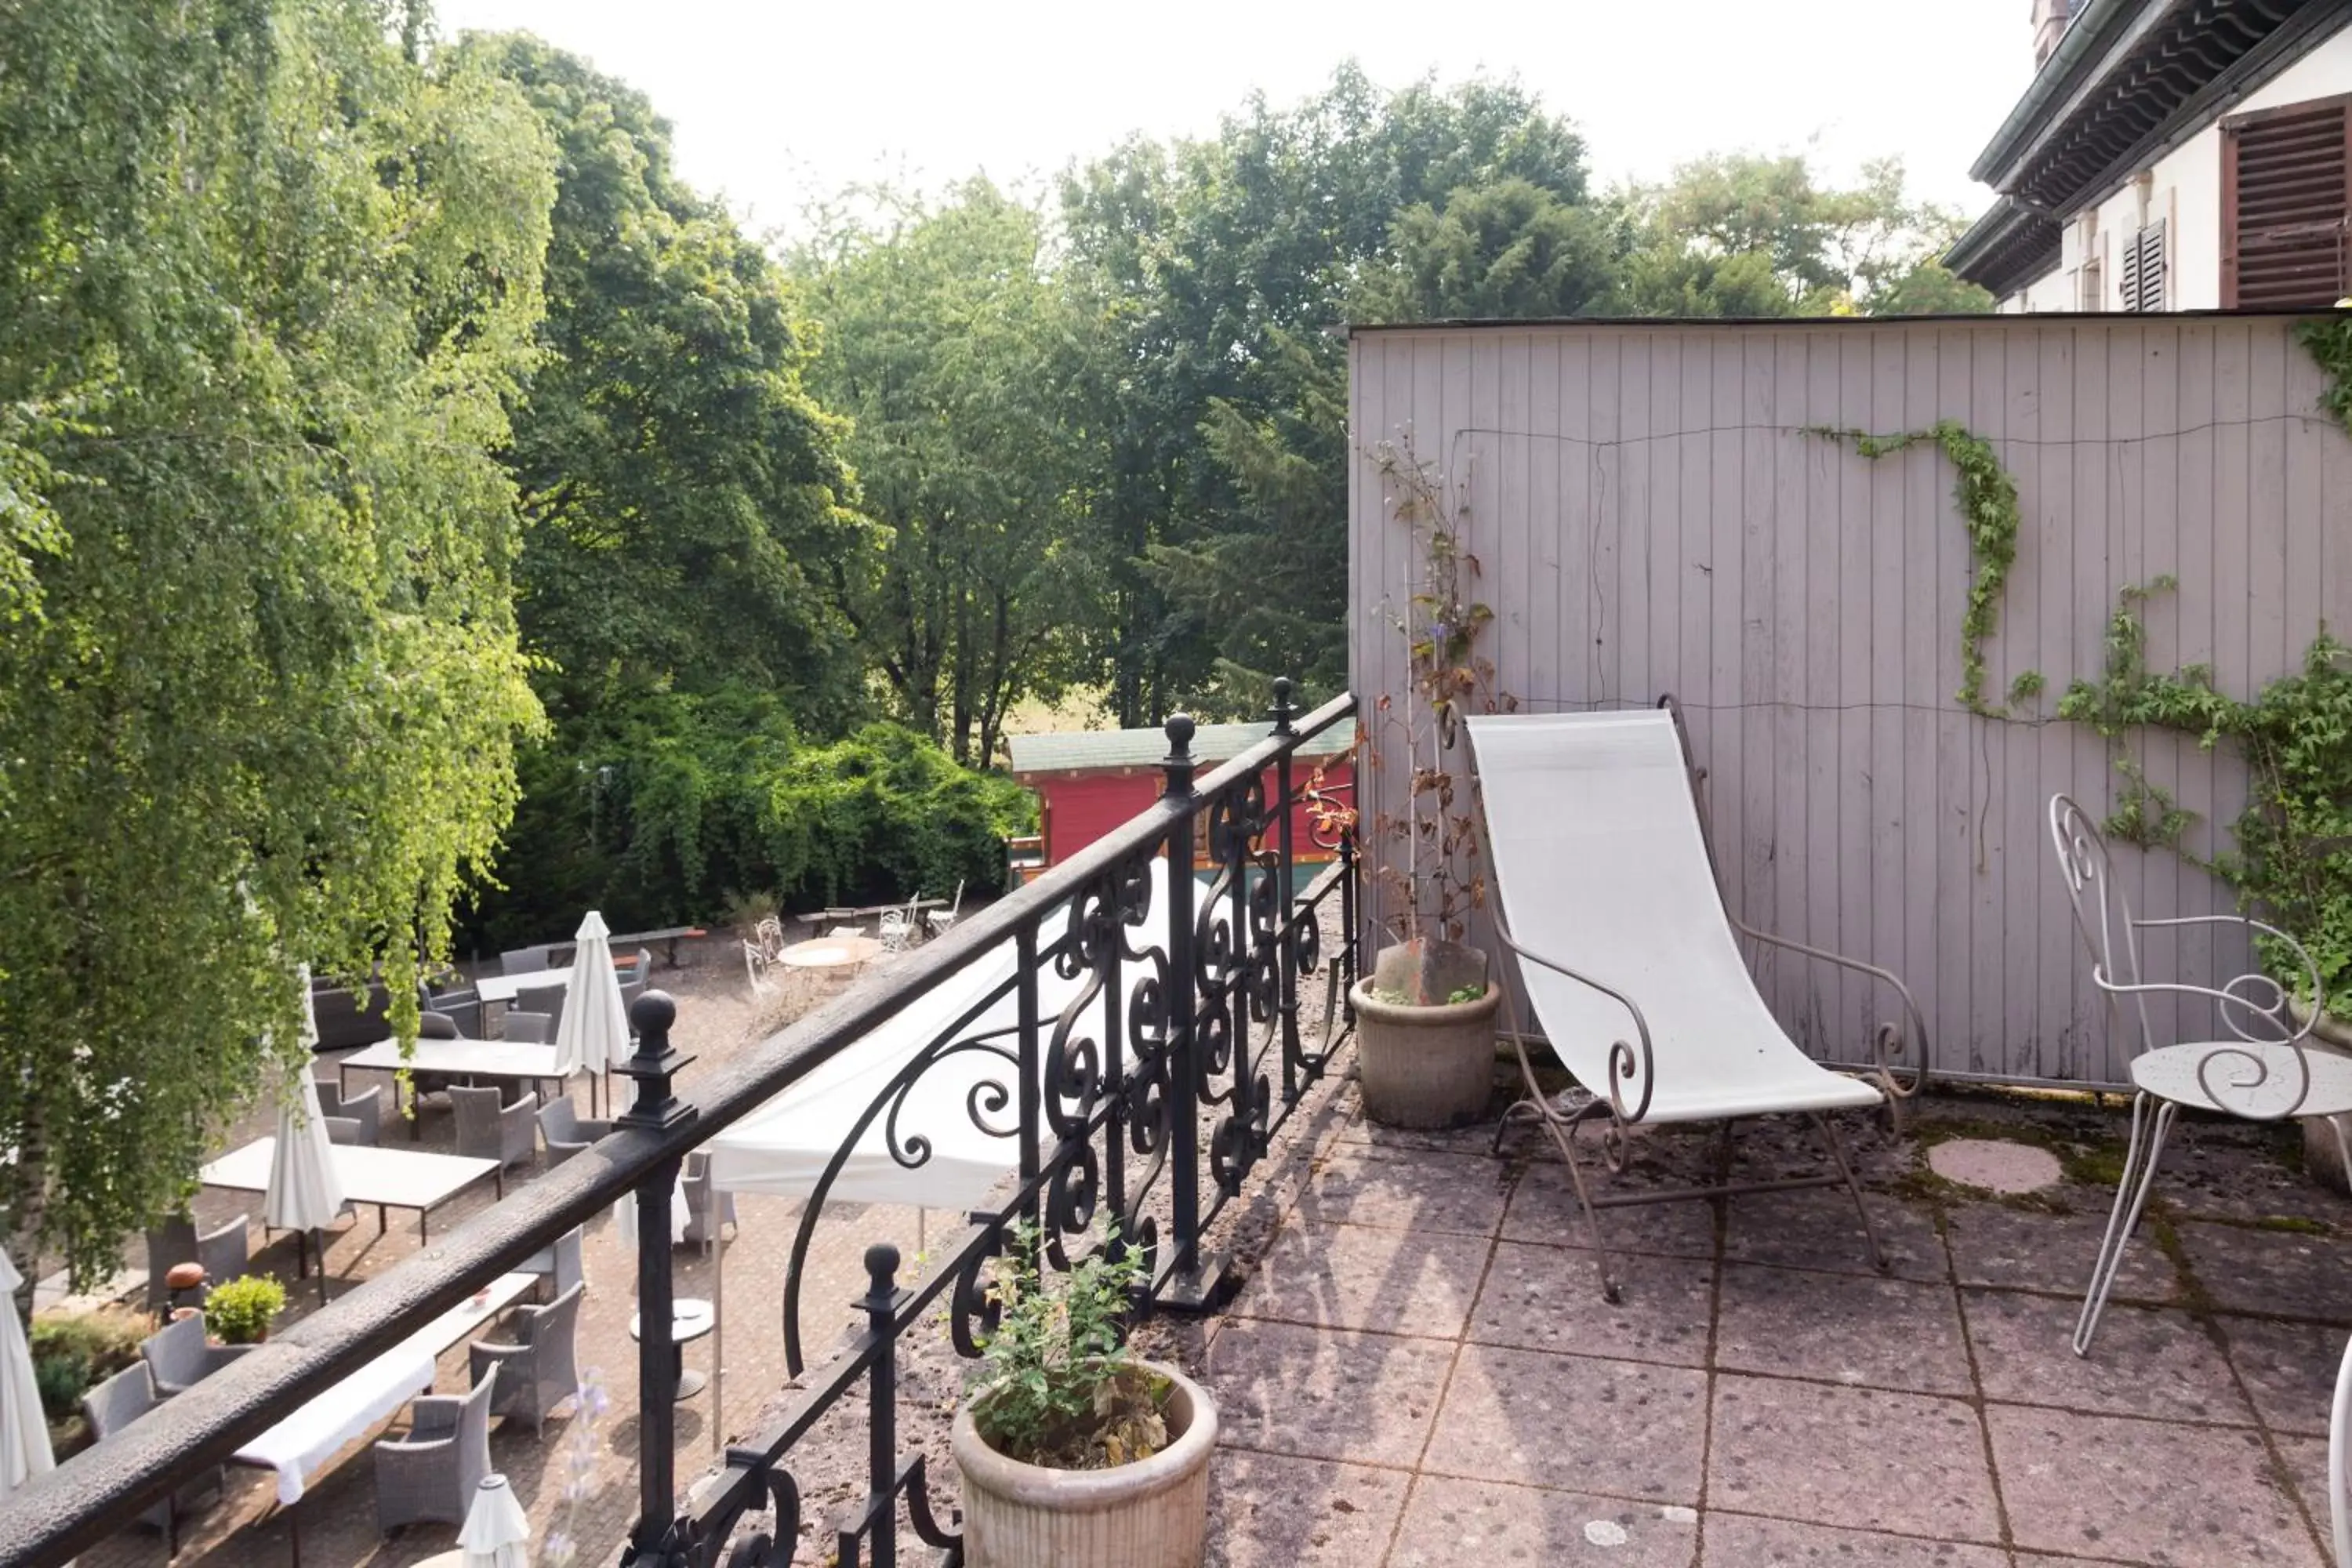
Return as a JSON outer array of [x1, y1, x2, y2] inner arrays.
[[1470, 699, 1926, 1300]]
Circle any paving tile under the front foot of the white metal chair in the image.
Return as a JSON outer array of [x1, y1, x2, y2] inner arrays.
[[1959, 1290, 2253, 1425]]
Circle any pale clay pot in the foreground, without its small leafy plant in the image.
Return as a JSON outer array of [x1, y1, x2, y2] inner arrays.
[[950, 1361, 1216, 1568]]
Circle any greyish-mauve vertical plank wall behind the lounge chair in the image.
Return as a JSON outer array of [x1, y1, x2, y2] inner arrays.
[[1350, 318, 2352, 1083]]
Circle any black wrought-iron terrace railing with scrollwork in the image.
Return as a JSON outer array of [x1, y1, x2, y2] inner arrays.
[[0, 682, 1357, 1568]]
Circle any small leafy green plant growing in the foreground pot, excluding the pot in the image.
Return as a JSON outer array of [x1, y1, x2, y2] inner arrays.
[[971, 1222, 1167, 1469]]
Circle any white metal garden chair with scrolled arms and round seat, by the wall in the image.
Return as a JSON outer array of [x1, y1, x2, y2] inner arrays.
[[2051, 794, 2352, 1356]]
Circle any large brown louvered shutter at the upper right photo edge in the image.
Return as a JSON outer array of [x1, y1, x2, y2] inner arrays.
[[2220, 96, 2352, 310]]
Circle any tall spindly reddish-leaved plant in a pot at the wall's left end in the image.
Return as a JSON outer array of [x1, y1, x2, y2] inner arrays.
[[1350, 442, 1517, 1126]]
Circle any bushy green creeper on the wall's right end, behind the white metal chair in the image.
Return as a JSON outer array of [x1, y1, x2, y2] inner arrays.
[[2058, 579, 2352, 996]]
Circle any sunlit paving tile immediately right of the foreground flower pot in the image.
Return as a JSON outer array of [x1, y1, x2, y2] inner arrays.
[[1202, 1323, 1454, 1467]]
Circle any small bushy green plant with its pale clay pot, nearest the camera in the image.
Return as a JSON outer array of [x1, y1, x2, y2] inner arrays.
[[950, 1227, 1216, 1568]]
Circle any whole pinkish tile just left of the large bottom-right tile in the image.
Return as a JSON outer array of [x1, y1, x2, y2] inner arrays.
[[1708, 1373, 1999, 1542]]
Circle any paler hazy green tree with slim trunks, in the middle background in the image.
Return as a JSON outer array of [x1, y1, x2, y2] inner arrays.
[[795, 179, 1101, 767]]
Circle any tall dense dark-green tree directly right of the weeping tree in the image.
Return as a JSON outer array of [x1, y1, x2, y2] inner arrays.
[[459, 35, 863, 722]]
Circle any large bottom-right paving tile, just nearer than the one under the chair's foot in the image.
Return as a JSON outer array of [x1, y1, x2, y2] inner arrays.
[[1985, 1406, 2324, 1568]]
